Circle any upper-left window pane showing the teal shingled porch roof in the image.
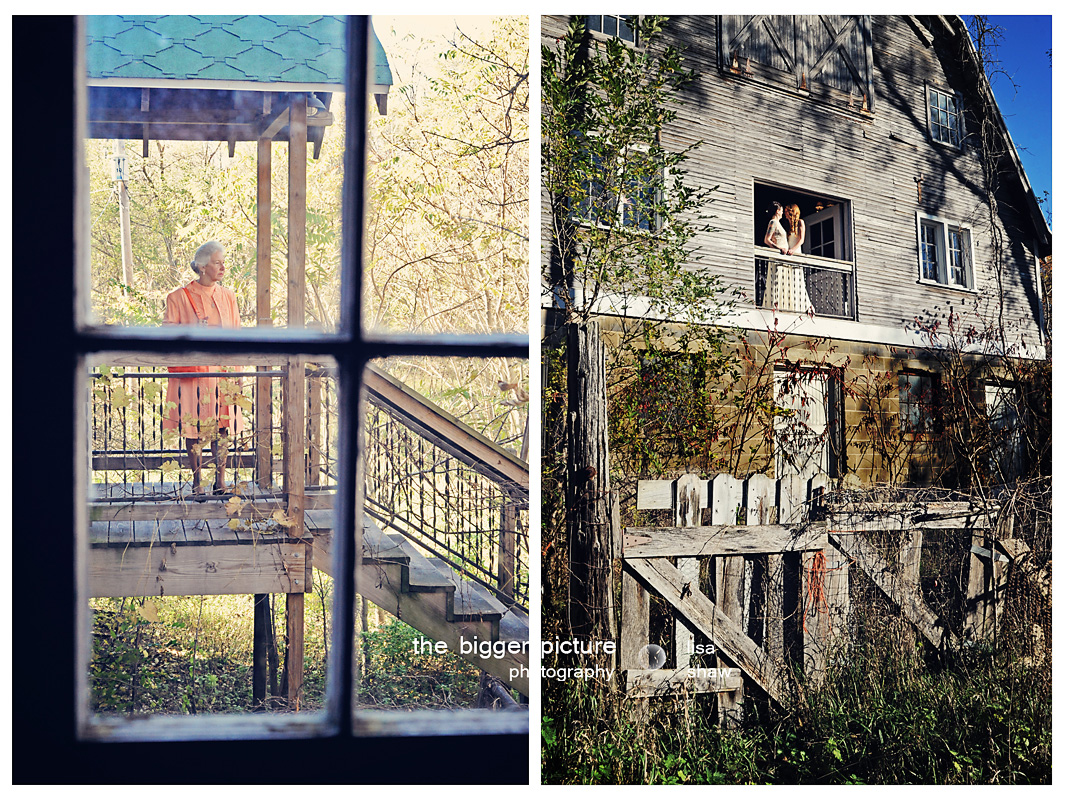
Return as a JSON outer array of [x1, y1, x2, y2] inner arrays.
[[84, 16, 349, 331]]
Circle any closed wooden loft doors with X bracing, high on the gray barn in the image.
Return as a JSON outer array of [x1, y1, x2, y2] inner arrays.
[[719, 14, 874, 110]]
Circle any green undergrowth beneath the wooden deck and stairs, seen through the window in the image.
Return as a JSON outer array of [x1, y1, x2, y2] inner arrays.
[[90, 574, 479, 715]]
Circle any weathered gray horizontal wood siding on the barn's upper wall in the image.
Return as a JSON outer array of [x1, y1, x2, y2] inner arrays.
[[542, 16, 1039, 343]]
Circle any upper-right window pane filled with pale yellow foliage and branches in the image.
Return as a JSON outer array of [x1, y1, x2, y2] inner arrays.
[[363, 17, 529, 334]]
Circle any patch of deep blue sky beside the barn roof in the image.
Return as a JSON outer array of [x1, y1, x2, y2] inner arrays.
[[964, 15, 1052, 220]]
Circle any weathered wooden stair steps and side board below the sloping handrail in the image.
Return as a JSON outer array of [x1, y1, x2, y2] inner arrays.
[[305, 511, 529, 695]]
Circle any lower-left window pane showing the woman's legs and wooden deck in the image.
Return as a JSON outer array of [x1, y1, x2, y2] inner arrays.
[[82, 353, 341, 735]]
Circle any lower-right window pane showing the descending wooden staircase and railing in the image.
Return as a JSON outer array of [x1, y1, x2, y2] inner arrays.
[[354, 358, 530, 709]]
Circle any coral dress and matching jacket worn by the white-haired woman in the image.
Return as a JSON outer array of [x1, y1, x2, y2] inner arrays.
[[163, 281, 243, 438]]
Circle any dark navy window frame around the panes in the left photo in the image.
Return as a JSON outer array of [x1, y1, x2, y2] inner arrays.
[[9, 16, 529, 784]]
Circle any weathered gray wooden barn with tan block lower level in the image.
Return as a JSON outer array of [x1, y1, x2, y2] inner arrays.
[[542, 15, 1051, 483]]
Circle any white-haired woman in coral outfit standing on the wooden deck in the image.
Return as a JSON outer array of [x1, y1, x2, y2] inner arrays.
[[163, 241, 242, 494]]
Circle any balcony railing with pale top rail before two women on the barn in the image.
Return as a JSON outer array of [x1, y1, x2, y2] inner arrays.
[[755, 250, 856, 319]]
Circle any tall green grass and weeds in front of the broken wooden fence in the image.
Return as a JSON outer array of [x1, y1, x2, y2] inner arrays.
[[541, 645, 1052, 784]]
